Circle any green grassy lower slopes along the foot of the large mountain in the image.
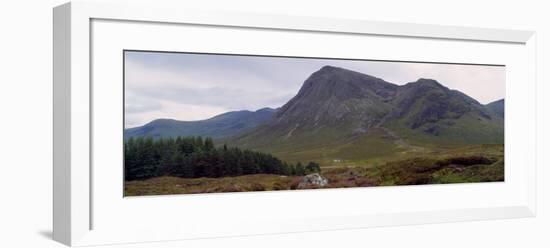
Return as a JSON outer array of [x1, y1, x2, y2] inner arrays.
[[230, 112, 504, 167]]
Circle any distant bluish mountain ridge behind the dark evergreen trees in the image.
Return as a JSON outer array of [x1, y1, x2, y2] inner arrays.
[[124, 108, 276, 139]]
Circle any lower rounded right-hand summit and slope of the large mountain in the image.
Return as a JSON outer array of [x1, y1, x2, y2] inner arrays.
[[385, 79, 504, 144]]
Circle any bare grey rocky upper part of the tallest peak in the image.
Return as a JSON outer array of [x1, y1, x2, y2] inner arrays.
[[272, 66, 397, 131]]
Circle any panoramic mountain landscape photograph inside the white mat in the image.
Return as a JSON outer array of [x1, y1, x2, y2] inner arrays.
[[123, 50, 506, 196]]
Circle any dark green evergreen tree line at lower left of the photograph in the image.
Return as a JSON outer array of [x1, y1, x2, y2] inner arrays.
[[124, 136, 321, 181]]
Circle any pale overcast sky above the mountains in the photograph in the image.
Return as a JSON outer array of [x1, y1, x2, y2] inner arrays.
[[124, 51, 505, 128]]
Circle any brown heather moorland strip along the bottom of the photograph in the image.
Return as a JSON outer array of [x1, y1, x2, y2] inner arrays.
[[124, 145, 504, 196]]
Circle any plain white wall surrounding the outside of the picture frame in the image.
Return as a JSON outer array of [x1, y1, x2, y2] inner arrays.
[[0, 0, 550, 248]]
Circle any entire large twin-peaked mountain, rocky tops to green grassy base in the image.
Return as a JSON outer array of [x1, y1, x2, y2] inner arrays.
[[229, 66, 504, 163]]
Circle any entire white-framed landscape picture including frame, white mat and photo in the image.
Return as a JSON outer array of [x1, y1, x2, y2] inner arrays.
[[54, 1, 536, 246]]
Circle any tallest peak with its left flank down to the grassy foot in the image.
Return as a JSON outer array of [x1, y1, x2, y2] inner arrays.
[[235, 66, 397, 148]]
